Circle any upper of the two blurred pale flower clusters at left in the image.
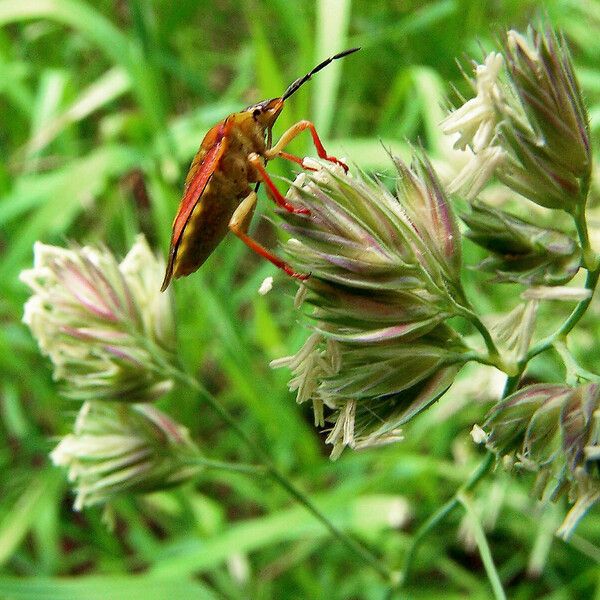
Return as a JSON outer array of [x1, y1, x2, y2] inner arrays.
[[21, 237, 174, 402]]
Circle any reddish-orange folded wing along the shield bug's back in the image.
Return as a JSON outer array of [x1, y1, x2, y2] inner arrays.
[[161, 123, 226, 291]]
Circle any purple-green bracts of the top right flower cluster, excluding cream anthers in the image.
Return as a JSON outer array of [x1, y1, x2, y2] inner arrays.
[[498, 30, 591, 212]]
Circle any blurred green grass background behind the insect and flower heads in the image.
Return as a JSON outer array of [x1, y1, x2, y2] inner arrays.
[[0, 0, 600, 600]]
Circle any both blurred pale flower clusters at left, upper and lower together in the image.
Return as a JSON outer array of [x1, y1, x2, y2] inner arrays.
[[21, 237, 206, 510]]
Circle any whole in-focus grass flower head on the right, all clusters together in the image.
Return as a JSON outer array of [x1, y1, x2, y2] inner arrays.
[[273, 24, 600, 536]]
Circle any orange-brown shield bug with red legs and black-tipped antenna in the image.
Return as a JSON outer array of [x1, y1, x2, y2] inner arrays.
[[161, 48, 359, 291]]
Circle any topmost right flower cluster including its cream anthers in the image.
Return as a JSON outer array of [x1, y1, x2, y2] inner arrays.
[[442, 29, 591, 213]]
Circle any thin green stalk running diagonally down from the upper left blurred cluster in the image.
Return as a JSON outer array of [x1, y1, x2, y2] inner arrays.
[[163, 364, 394, 581]]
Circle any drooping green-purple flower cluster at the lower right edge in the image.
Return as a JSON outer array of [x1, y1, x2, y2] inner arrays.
[[483, 383, 600, 539]]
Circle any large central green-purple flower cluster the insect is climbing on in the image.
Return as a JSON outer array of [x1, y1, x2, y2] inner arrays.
[[272, 160, 474, 457]]
